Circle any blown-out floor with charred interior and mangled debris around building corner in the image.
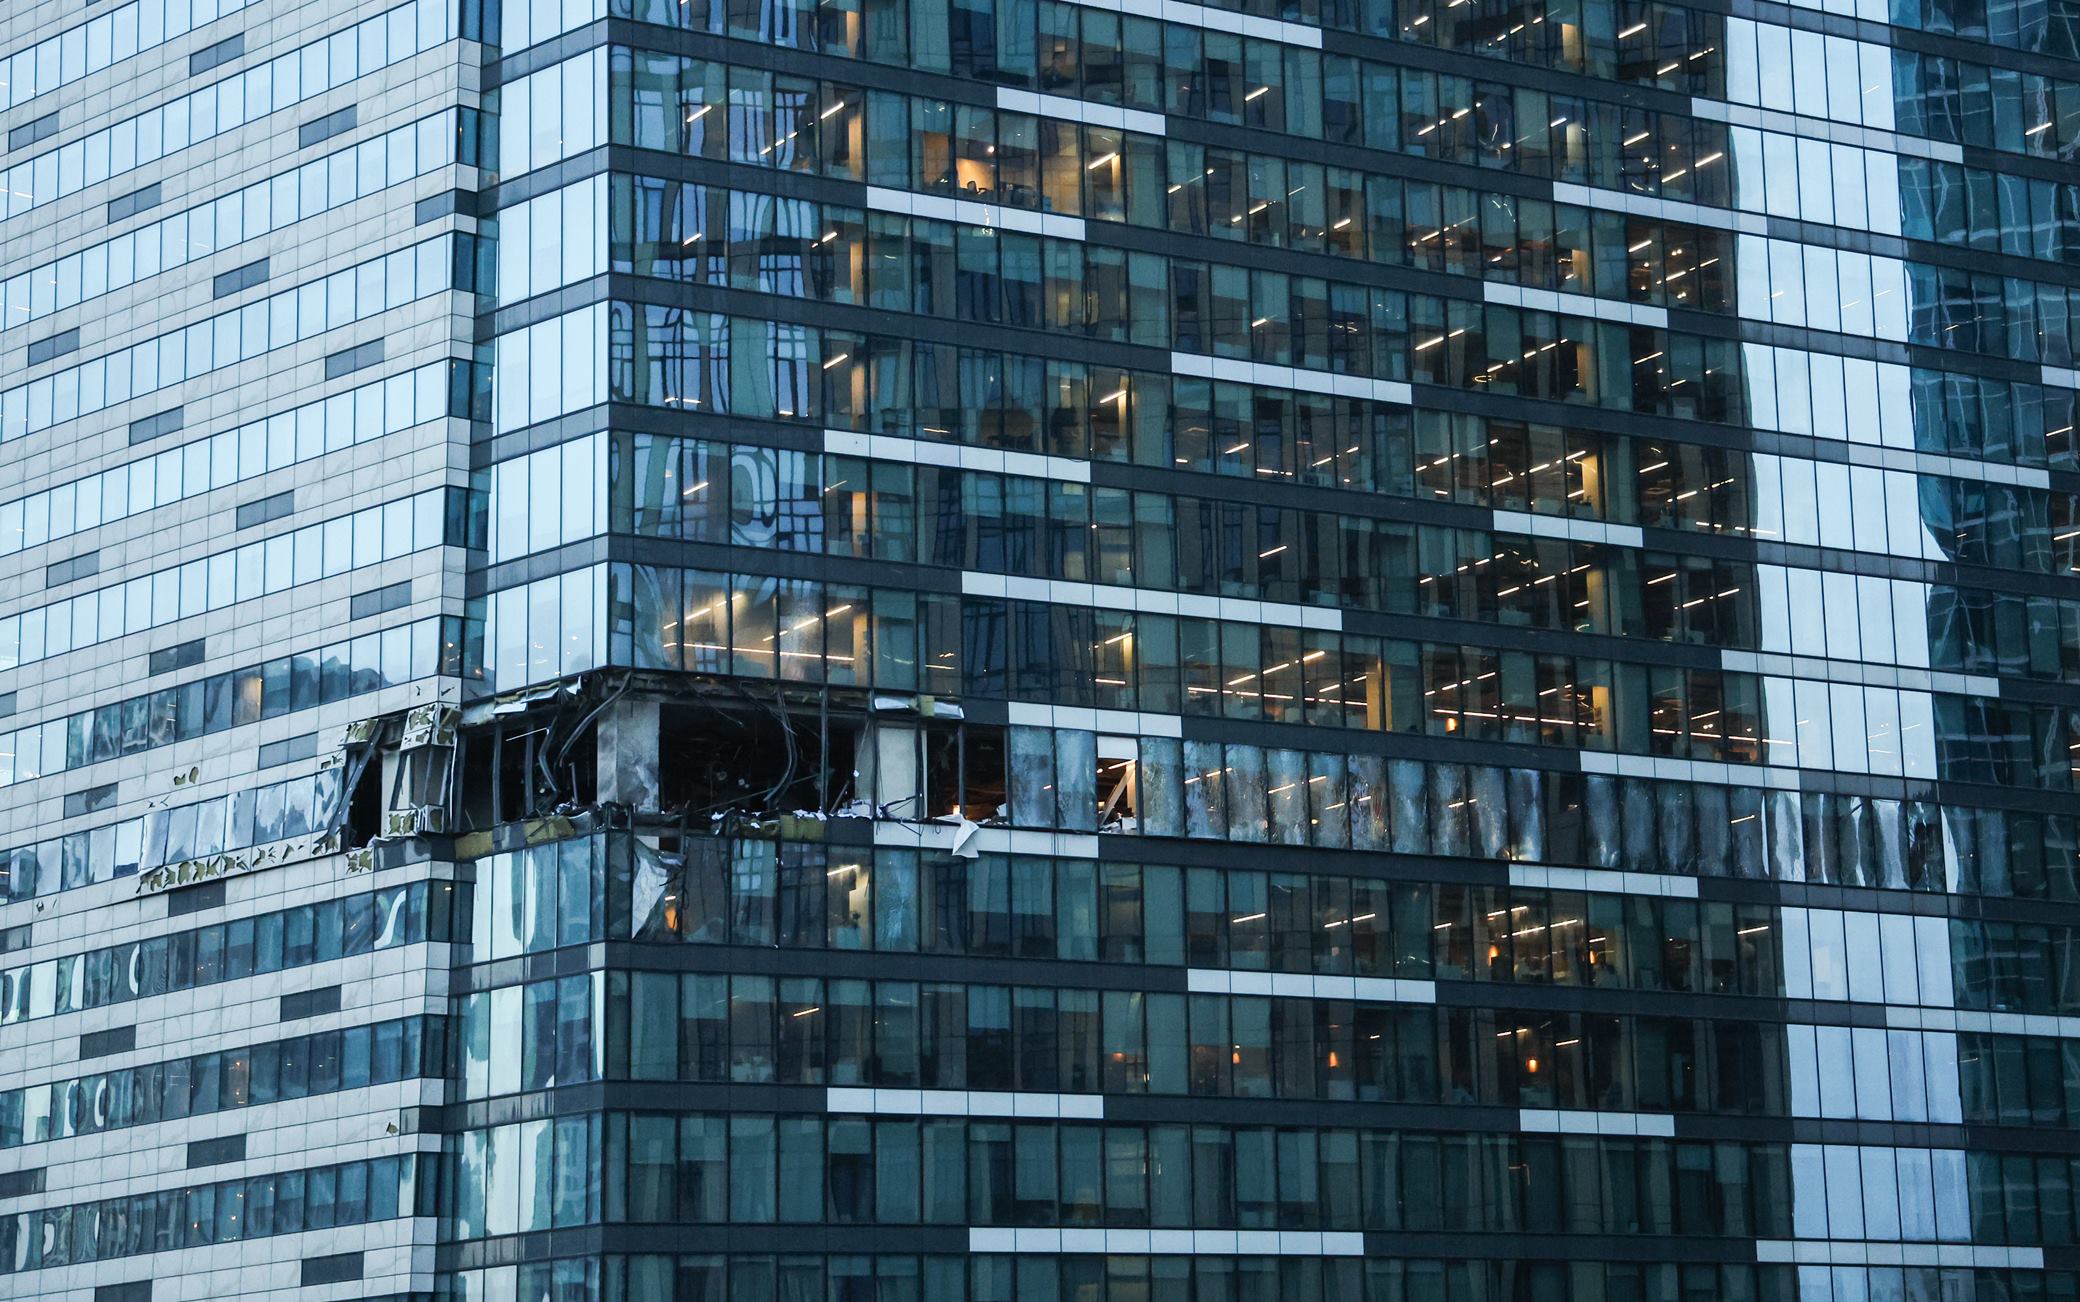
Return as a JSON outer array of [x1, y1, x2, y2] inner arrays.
[[341, 674, 1089, 849]]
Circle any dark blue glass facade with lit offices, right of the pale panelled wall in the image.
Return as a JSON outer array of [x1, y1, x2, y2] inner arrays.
[[459, 0, 2080, 1302]]
